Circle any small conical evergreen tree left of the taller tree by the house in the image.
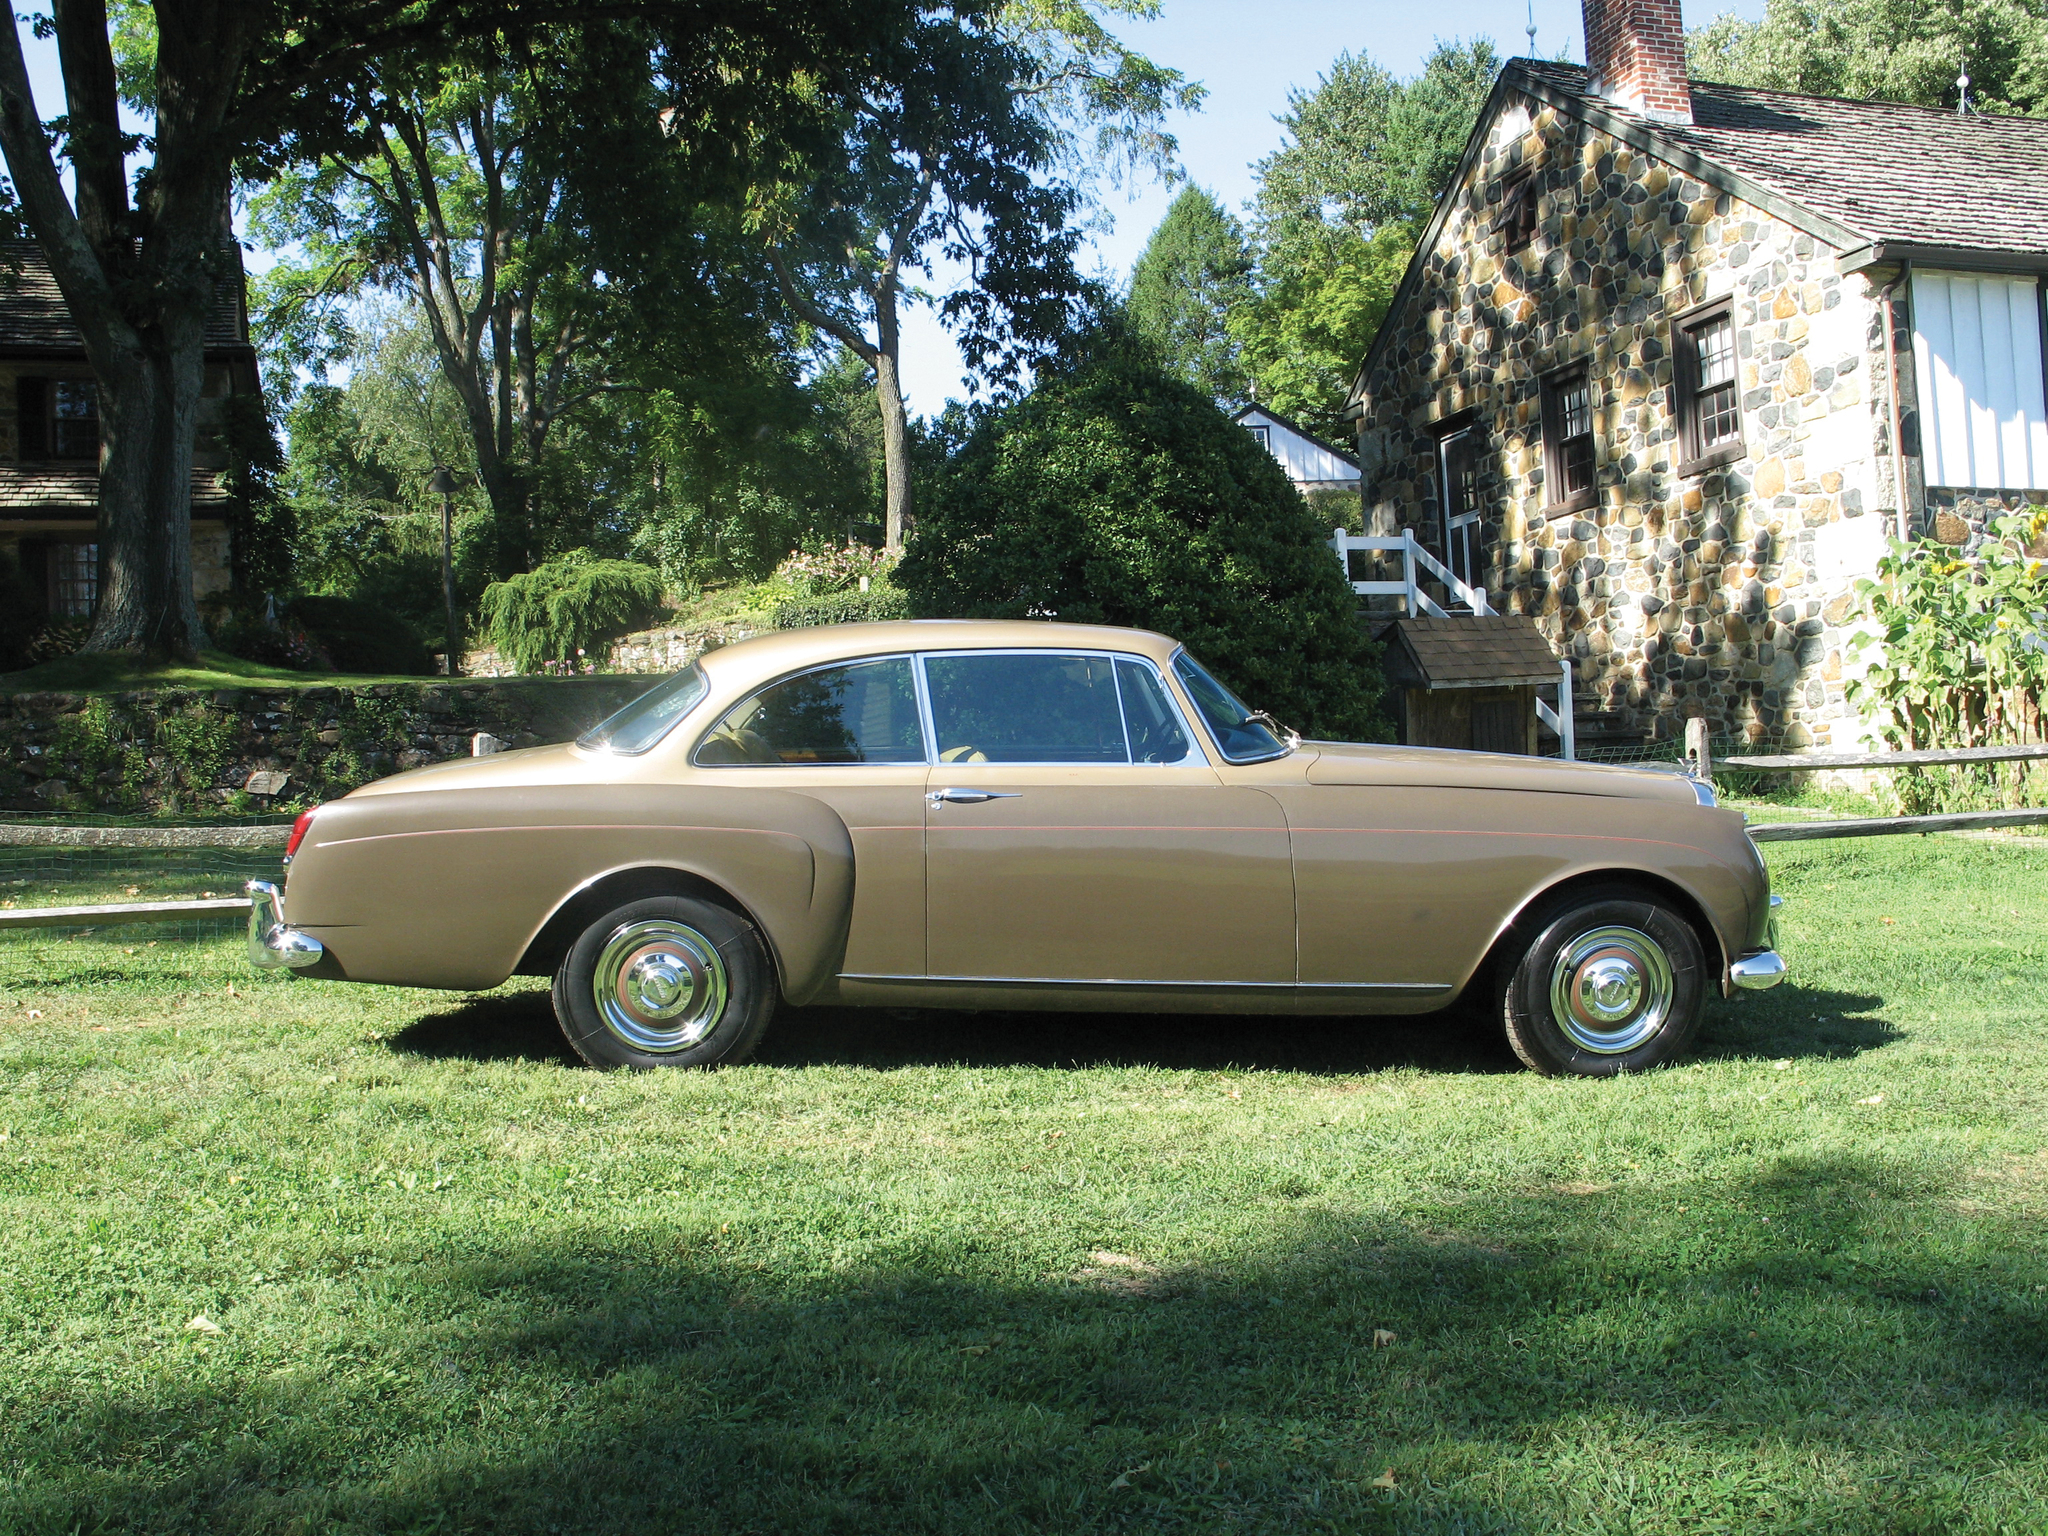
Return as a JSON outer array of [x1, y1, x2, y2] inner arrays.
[[1124, 186, 1251, 401]]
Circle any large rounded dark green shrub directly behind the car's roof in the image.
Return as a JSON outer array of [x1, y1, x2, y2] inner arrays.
[[895, 348, 1386, 739]]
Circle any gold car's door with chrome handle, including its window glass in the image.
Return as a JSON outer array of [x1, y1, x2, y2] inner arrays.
[[920, 649, 1294, 991]]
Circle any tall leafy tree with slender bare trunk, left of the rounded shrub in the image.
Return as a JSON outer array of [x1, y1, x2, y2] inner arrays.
[[752, 0, 1200, 549]]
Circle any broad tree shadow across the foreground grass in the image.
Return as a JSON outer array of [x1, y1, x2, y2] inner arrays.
[[0, 1153, 2048, 1536]]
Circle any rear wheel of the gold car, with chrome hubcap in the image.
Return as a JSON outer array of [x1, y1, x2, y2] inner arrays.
[[553, 897, 776, 1071]]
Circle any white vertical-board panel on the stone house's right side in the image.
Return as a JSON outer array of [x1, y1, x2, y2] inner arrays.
[[1913, 272, 2048, 492]]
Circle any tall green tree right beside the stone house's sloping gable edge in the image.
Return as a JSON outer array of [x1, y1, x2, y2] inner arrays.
[[1231, 39, 1499, 438]]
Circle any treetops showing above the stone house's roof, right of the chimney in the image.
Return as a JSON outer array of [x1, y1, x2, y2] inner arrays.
[[1686, 0, 2048, 117]]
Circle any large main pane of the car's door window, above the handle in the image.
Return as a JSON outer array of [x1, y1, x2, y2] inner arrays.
[[924, 651, 1130, 762]]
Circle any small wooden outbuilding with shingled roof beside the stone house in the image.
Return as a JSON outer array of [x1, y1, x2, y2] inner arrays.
[[1380, 614, 1561, 758]]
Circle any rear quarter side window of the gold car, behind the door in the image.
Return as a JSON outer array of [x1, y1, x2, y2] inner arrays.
[[694, 655, 924, 768]]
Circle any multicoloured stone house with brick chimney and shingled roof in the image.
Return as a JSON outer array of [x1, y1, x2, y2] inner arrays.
[[1348, 0, 2048, 748]]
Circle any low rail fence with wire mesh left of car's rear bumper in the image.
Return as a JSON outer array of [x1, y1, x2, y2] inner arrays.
[[0, 825, 283, 944]]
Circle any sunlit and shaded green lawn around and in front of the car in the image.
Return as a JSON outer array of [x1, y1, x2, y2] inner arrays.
[[0, 838, 2048, 1536]]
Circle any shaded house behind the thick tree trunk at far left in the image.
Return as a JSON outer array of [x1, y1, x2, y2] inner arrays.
[[0, 240, 262, 618]]
